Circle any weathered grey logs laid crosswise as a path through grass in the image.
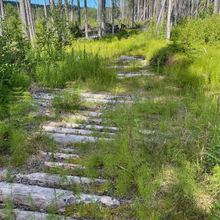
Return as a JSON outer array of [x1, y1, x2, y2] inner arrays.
[[0, 56, 150, 220]]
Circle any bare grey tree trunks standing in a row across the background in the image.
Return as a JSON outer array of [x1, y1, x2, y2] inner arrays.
[[0, 0, 220, 41]]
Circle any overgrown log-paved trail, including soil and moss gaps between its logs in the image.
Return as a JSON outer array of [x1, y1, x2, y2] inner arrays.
[[0, 56, 154, 220]]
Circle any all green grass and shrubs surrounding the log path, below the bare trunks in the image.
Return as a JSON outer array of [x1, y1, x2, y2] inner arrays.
[[0, 6, 220, 220]]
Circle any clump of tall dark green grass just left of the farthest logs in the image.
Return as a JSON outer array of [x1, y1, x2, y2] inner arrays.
[[35, 48, 116, 88]]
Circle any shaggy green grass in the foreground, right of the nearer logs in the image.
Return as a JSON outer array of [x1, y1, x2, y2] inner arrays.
[[66, 78, 219, 219]]
